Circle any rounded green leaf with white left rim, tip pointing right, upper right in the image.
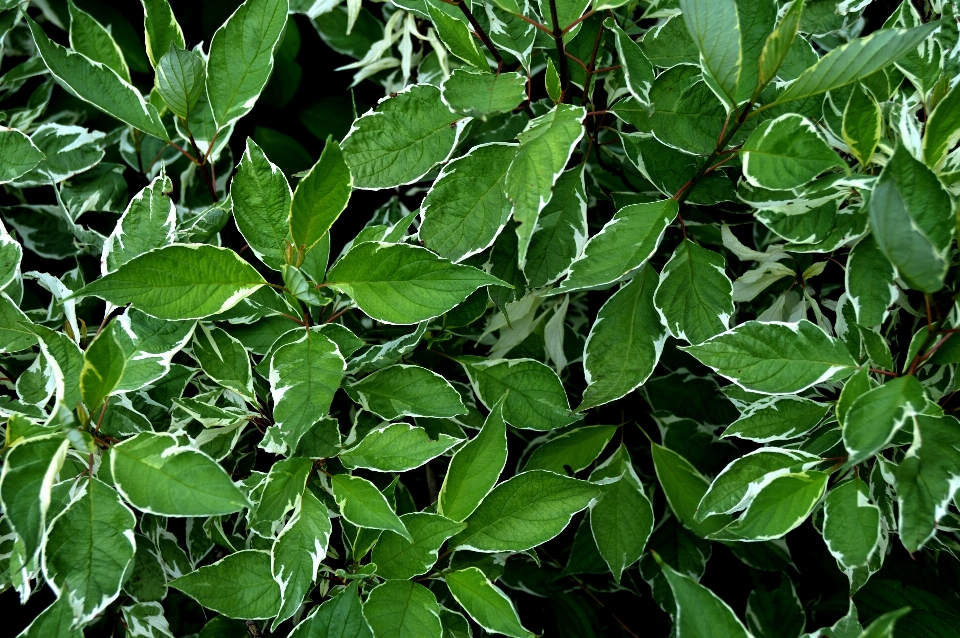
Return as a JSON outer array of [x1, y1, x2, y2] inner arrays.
[[743, 113, 847, 190]]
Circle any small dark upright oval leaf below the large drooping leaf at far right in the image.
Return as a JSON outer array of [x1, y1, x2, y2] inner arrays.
[[845, 235, 897, 328]]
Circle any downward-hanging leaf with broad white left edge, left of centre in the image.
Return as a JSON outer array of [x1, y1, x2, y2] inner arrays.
[[269, 328, 345, 452]]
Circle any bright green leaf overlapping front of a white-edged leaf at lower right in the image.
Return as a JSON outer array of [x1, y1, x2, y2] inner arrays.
[[715, 470, 830, 541]]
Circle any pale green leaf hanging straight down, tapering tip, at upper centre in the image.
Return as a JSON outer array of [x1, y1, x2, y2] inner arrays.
[[504, 104, 586, 267]]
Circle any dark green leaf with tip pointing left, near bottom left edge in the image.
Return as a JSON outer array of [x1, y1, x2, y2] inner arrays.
[[170, 549, 280, 620]]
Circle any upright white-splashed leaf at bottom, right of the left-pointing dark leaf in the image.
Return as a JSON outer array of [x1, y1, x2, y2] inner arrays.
[[272, 490, 333, 629]]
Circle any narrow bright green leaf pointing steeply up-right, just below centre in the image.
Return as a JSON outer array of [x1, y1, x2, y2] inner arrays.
[[437, 398, 507, 522]]
